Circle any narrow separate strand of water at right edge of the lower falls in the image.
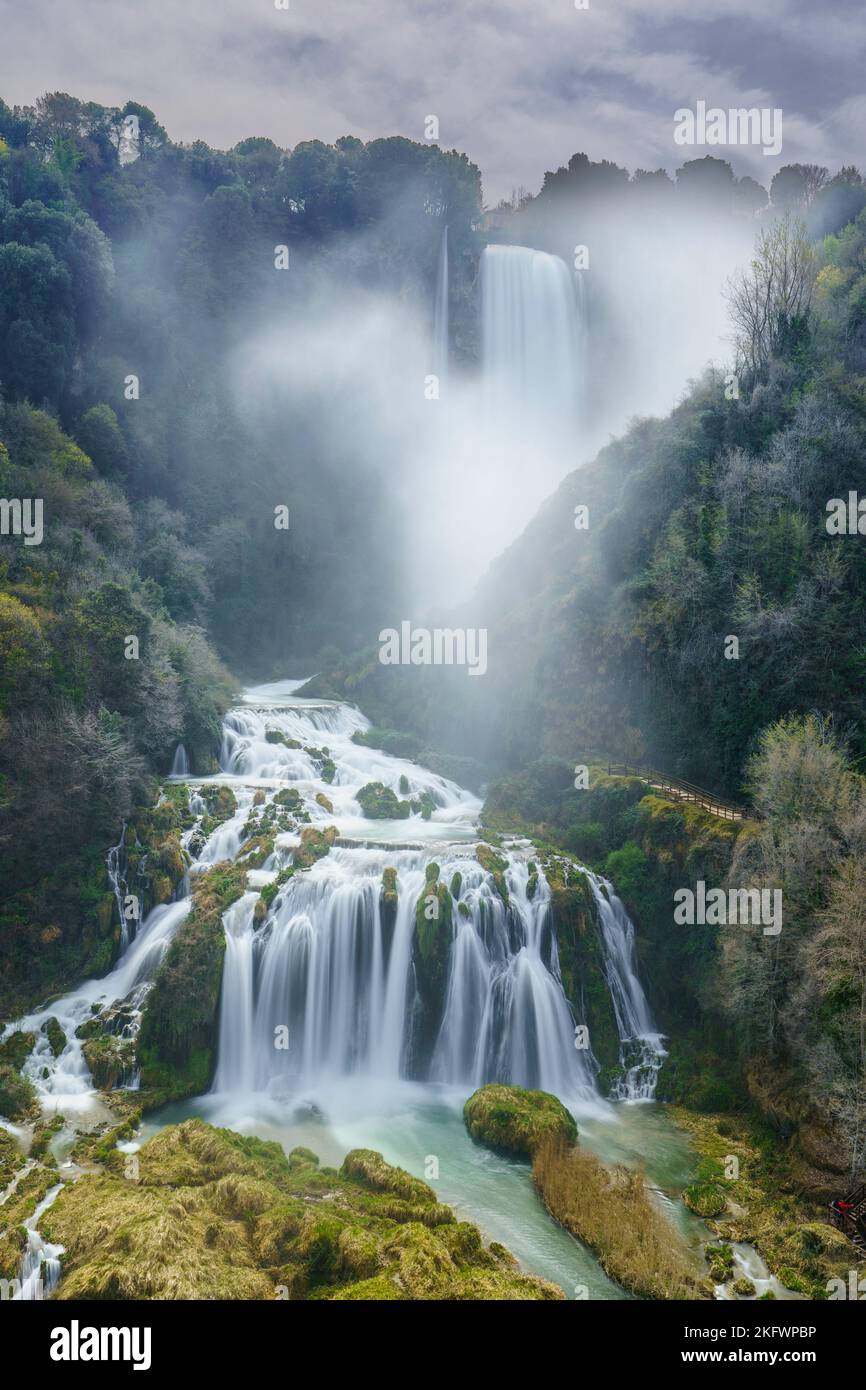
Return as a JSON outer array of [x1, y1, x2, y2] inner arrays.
[[587, 873, 666, 1101]]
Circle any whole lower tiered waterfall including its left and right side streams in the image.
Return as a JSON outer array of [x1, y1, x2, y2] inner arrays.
[[3, 687, 664, 1128]]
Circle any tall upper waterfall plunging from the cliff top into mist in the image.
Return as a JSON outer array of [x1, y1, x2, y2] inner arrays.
[[481, 246, 585, 444]]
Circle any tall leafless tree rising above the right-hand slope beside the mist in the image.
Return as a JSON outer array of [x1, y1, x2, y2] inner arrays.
[[727, 213, 817, 381]]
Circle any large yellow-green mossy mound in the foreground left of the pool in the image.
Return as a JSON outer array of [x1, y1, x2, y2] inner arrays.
[[43, 1120, 563, 1301]]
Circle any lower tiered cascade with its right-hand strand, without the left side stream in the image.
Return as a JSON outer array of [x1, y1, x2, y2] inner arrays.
[[199, 689, 652, 1104]]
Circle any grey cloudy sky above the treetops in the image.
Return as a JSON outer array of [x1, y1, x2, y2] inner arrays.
[[0, 0, 866, 203]]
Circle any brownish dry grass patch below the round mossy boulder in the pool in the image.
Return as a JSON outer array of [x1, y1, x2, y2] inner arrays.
[[532, 1138, 712, 1300]]
